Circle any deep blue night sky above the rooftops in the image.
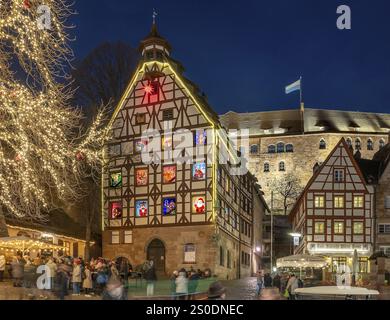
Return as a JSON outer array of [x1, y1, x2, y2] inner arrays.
[[72, 0, 390, 113]]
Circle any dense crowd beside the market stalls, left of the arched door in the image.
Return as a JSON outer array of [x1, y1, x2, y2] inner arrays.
[[0, 255, 132, 300]]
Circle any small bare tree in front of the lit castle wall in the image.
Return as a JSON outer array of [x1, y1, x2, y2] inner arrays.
[[270, 173, 303, 215]]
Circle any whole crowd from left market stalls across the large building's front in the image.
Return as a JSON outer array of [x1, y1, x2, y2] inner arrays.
[[0, 254, 225, 300]]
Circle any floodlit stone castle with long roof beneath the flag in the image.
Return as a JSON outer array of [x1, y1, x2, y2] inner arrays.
[[220, 108, 390, 213]]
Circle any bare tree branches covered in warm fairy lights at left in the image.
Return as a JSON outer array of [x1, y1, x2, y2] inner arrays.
[[0, 0, 108, 218]]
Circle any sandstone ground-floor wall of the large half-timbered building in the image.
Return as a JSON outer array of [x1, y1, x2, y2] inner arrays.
[[103, 225, 252, 280]]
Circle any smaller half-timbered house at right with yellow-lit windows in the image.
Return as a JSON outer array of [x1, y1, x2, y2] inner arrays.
[[290, 139, 374, 273]]
